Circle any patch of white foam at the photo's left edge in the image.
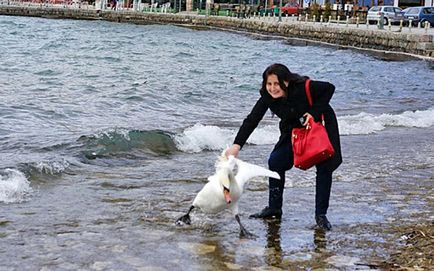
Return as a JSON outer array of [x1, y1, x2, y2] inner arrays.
[[0, 169, 33, 203]]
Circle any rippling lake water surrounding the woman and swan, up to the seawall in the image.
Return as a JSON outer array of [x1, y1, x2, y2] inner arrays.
[[0, 16, 434, 270]]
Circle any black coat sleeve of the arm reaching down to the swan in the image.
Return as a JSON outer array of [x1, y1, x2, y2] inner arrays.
[[234, 97, 268, 148]]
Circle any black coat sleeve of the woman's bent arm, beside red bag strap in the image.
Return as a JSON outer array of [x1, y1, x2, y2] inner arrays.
[[307, 81, 335, 120]]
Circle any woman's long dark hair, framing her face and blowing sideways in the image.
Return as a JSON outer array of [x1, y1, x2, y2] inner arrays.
[[260, 63, 309, 93]]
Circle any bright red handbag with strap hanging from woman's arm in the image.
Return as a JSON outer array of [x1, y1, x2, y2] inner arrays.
[[291, 80, 335, 170]]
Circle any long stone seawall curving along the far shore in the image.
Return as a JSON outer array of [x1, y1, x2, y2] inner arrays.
[[0, 6, 434, 60]]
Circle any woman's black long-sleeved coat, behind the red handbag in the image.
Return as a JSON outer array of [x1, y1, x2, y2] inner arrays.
[[234, 80, 342, 171]]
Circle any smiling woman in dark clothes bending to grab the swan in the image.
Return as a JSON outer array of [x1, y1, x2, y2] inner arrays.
[[226, 64, 342, 230]]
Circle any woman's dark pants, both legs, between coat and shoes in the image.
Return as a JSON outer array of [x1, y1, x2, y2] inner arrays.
[[268, 140, 333, 215]]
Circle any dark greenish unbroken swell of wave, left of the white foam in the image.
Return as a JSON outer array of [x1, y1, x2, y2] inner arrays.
[[78, 129, 178, 159]]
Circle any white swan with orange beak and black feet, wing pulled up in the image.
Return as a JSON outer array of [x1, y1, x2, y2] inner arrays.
[[176, 152, 280, 236]]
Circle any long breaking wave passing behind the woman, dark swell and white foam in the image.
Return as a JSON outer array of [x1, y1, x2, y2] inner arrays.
[[36, 108, 434, 160]]
